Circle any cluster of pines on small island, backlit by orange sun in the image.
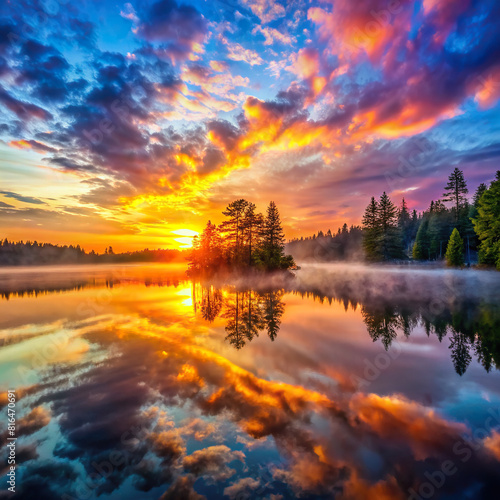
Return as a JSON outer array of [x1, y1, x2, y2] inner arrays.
[[188, 199, 295, 275]]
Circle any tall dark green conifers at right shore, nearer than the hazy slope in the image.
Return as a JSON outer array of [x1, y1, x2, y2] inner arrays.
[[363, 168, 500, 269]]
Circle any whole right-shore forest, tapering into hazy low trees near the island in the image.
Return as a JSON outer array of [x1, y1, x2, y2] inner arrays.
[[286, 168, 500, 269]]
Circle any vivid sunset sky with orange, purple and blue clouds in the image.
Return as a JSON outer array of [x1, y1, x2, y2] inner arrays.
[[0, 0, 500, 251]]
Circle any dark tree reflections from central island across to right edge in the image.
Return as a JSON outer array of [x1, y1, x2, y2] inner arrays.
[[188, 284, 500, 375]]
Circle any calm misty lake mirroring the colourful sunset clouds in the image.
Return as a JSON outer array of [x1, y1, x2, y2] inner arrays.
[[0, 264, 500, 500]]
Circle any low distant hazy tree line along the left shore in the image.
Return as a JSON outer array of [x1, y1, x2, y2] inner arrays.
[[0, 238, 183, 266]]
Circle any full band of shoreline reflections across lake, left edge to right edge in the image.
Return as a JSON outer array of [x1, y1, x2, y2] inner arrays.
[[0, 269, 500, 375]]
